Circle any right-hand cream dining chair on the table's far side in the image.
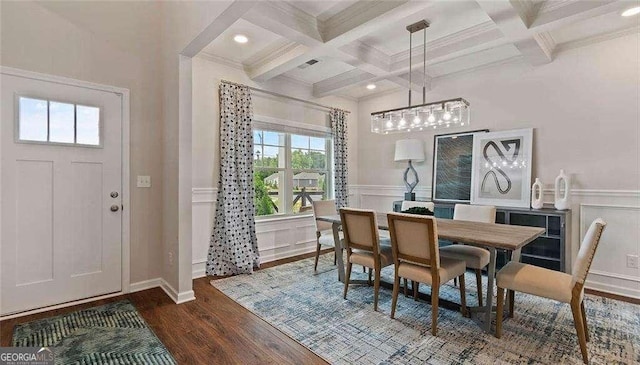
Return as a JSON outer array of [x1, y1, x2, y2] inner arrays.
[[440, 204, 496, 307]]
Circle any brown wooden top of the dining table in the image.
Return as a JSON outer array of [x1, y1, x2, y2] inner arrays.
[[316, 213, 545, 250]]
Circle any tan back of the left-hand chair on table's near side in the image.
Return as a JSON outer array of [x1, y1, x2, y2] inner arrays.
[[340, 208, 380, 253]]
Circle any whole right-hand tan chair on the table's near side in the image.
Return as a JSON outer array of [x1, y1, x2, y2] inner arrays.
[[387, 213, 467, 336]]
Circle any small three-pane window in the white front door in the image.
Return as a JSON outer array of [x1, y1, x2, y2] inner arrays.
[[17, 96, 100, 146]]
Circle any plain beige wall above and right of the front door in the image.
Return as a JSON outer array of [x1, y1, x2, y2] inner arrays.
[[0, 1, 163, 285]]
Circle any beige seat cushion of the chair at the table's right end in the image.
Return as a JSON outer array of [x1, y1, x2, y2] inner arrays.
[[497, 261, 582, 303]]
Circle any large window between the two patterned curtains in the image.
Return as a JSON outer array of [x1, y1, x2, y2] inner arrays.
[[253, 129, 332, 216]]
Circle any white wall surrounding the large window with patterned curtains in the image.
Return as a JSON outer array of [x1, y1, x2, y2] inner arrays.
[[192, 56, 358, 276]]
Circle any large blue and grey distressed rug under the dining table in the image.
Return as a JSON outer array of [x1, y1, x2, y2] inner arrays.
[[211, 254, 640, 364]]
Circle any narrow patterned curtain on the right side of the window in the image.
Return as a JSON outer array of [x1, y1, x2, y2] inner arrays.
[[329, 109, 349, 209]]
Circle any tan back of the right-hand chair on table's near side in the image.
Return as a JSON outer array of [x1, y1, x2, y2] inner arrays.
[[387, 213, 440, 270]]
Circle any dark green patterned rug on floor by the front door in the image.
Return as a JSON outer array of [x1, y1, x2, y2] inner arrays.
[[12, 300, 176, 365]]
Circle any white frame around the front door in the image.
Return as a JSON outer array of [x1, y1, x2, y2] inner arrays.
[[0, 66, 131, 310]]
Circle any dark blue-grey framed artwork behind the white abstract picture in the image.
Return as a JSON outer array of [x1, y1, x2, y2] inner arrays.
[[431, 129, 489, 203]]
